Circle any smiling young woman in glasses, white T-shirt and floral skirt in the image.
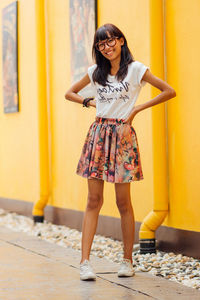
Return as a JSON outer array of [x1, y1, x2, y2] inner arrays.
[[65, 24, 176, 280]]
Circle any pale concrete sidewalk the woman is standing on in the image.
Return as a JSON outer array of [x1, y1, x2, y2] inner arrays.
[[0, 227, 200, 300]]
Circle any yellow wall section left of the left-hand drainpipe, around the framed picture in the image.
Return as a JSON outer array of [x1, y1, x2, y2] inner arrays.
[[0, 0, 39, 201]]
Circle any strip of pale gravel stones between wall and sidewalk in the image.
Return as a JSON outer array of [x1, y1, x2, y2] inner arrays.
[[0, 209, 200, 290]]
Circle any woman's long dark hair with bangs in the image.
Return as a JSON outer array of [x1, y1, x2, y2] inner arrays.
[[92, 24, 134, 86]]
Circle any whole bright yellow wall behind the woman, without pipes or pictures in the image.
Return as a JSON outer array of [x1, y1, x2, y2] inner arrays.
[[0, 0, 200, 231]]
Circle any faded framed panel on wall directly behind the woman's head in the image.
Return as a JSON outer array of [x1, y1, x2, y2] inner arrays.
[[70, 0, 97, 86]]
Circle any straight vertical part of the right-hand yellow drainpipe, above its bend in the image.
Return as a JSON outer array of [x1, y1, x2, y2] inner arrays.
[[150, 0, 168, 210]]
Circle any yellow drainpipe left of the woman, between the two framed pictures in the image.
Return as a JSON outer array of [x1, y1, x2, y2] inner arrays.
[[32, 0, 49, 220]]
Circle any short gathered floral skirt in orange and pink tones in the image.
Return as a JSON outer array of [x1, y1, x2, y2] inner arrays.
[[76, 117, 143, 183]]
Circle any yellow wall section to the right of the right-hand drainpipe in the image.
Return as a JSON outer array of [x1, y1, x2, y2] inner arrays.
[[166, 0, 200, 231]]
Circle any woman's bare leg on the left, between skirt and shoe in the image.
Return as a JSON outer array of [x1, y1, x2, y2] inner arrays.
[[80, 179, 104, 263]]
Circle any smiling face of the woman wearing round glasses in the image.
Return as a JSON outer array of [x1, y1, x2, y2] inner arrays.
[[97, 33, 124, 61]]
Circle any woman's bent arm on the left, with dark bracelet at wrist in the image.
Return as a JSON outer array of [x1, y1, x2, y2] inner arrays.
[[65, 74, 96, 107]]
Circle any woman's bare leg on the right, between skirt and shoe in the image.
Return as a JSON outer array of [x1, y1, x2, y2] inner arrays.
[[115, 183, 135, 262]]
